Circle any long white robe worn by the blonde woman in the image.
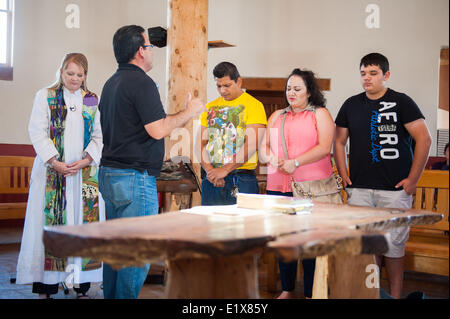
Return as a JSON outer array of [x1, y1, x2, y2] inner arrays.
[[16, 88, 105, 286]]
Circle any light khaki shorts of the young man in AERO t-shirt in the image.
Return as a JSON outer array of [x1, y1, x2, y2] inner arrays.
[[347, 188, 413, 258]]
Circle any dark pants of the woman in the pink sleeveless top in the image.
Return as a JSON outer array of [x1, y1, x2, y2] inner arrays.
[[267, 190, 316, 298]]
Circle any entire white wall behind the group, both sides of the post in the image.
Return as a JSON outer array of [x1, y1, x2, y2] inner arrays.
[[0, 0, 449, 154]]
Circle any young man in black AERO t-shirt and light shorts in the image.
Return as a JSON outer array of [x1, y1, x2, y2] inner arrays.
[[334, 53, 431, 298]]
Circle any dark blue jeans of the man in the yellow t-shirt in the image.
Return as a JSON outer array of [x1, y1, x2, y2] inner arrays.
[[202, 170, 259, 206]]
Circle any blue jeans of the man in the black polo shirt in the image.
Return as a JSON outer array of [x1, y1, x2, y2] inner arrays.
[[98, 166, 158, 299]]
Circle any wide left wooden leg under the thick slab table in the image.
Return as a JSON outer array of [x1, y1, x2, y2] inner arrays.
[[165, 255, 259, 299]]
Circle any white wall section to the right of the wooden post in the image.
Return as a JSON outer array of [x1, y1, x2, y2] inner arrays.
[[208, 0, 449, 154]]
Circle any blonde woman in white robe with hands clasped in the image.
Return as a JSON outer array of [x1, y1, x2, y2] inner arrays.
[[16, 53, 105, 298]]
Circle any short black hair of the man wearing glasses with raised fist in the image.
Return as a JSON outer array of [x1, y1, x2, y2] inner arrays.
[[113, 25, 145, 63]]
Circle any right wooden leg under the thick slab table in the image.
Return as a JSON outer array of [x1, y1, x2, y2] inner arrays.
[[313, 254, 380, 299]]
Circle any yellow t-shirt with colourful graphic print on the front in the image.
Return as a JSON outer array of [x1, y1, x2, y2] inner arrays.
[[201, 92, 267, 169]]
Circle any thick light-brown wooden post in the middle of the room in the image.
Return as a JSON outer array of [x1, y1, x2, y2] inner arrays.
[[165, 0, 208, 206]]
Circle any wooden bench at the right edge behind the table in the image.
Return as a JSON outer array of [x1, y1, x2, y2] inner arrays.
[[405, 170, 449, 276]]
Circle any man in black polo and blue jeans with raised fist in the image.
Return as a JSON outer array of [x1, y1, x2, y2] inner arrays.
[[99, 25, 206, 299]]
